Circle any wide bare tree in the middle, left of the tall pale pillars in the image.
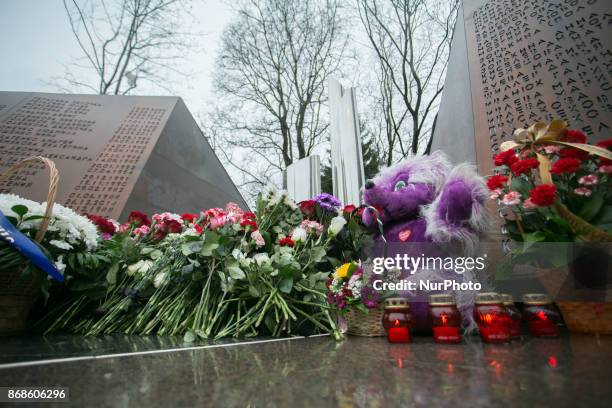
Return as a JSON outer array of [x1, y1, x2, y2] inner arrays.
[[214, 0, 347, 199]]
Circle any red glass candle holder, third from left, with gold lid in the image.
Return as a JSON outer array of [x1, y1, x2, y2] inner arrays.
[[474, 292, 510, 343]]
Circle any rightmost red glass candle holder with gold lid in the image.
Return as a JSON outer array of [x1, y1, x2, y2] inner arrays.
[[523, 293, 561, 337]]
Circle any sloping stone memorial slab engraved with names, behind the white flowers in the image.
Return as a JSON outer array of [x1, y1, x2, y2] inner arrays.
[[0, 92, 247, 219]]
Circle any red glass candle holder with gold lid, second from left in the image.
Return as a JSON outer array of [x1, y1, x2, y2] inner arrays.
[[429, 294, 461, 343]]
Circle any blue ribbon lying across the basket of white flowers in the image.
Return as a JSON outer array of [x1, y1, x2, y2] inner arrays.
[[0, 211, 64, 282]]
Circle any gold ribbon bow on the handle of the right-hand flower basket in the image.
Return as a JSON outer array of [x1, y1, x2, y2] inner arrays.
[[500, 119, 612, 184]]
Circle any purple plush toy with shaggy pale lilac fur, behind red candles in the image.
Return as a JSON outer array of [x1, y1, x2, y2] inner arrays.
[[362, 152, 488, 331]]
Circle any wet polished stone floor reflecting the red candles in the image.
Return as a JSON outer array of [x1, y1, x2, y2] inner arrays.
[[0, 334, 612, 408]]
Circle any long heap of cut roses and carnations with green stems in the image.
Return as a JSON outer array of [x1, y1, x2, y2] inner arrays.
[[44, 190, 369, 341]]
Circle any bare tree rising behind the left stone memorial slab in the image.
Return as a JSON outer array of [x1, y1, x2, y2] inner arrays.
[[56, 0, 192, 95]]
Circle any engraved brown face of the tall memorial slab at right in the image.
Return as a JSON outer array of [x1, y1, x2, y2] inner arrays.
[[464, 0, 612, 174]]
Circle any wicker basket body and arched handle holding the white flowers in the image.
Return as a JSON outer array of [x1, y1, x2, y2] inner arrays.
[[0, 156, 59, 336]]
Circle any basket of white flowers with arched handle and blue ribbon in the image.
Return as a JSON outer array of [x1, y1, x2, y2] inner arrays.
[[0, 157, 98, 334]]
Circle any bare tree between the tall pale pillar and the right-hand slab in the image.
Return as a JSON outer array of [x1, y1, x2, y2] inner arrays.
[[357, 0, 459, 165]]
